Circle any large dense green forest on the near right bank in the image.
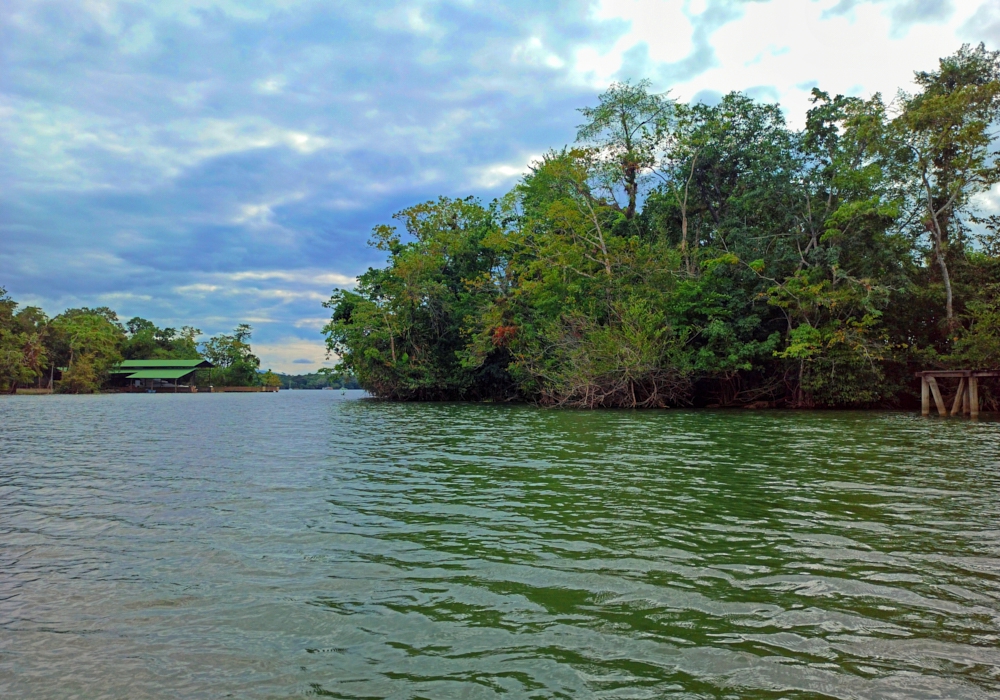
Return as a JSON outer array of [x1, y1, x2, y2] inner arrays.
[[324, 44, 1000, 408]]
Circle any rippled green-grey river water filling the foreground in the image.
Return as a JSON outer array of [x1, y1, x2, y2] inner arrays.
[[0, 391, 1000, 699]]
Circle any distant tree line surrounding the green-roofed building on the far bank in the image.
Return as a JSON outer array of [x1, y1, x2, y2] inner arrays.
[[0, 287, 279, 394]]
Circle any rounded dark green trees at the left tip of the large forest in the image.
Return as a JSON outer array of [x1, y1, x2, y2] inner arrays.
[[325, 198, 512, 400]]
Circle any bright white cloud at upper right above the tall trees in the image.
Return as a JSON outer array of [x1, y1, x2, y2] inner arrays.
[[570, 0, 996, 126]]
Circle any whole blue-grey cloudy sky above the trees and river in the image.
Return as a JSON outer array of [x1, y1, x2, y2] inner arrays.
[[0, 0, 1000, 373]]
